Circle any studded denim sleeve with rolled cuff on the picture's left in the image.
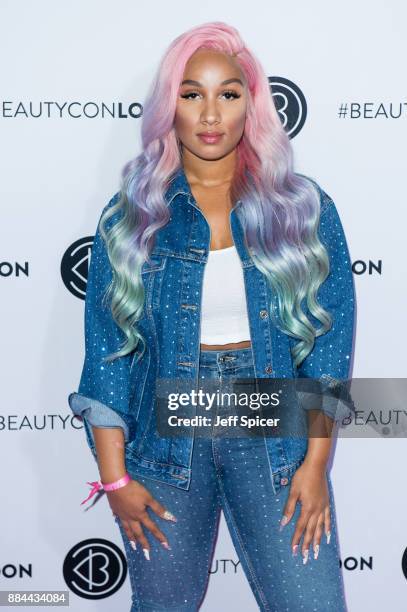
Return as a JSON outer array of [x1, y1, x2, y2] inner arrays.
[[68, 193, 132, 459]]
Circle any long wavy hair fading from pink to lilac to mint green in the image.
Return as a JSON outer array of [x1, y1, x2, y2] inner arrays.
[[99, 22, 332, 366]]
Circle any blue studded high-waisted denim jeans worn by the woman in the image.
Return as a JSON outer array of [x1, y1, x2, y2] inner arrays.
[[116, 347, 346, 612]]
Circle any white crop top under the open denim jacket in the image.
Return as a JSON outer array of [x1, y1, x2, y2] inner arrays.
[[200, 246, 250, 344]]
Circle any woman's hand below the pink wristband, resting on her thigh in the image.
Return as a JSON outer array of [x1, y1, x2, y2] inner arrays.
[[106, 480, 177, 560]]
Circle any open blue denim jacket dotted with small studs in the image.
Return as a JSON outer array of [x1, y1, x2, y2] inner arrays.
[[68, 167, 355, 492]]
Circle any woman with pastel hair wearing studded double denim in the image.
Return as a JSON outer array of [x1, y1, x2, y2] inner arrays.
[[69, 22, 354, 612]]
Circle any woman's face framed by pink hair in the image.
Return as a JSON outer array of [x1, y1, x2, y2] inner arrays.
[[174, 49, 248, 160]]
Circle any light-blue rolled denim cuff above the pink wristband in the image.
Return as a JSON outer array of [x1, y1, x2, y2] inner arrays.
[[68, 392, 129, 449]]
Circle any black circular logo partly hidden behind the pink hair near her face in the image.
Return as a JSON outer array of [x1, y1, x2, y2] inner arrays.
[[268, 76, 307, 138]]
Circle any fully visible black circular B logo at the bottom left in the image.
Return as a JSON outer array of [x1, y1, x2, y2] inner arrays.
[[63, 538, 127, 599]]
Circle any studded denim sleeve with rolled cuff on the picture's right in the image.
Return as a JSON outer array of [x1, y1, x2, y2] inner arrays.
[[297, 187, 356, 420]]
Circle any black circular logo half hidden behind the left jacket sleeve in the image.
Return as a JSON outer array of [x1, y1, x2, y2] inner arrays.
[[61, 236, 94, 300]]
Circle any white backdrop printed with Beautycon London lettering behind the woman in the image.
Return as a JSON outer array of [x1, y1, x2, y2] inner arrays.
[[0, 0, 407, 612]]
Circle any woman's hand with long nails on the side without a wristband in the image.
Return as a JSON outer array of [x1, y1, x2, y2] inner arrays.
[[280, 458, 331, 564]]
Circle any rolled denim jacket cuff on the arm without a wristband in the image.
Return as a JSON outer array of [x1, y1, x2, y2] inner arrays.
[[297, 374, 355, 421]]
